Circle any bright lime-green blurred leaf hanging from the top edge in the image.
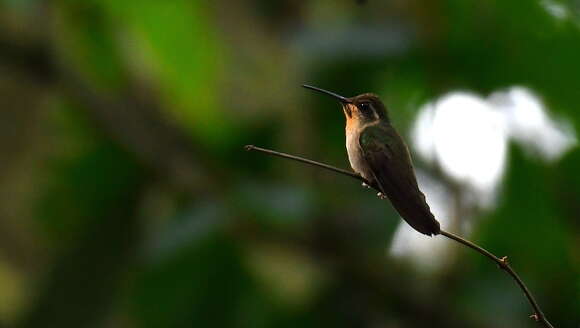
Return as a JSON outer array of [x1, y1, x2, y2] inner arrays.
[[98, 0, 232, 145]]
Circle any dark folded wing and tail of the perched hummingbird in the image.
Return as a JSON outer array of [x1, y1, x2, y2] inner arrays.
[[359, 125, 439, 235]]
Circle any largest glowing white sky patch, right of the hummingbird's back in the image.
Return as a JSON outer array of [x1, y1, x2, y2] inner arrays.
[[412, 87, 577, 206]]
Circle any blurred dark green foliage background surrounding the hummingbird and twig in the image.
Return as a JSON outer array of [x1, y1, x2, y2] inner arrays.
[[0, 0, 580, 327]]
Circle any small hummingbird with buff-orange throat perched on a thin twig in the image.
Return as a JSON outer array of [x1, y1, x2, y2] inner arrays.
[[303, 85, 440, 236]]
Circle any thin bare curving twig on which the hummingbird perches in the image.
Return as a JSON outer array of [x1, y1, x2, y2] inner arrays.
[[244, 145, 554, 328]]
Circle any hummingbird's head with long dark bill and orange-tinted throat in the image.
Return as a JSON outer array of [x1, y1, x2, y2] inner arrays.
[[303, 85, 389, 124]]
